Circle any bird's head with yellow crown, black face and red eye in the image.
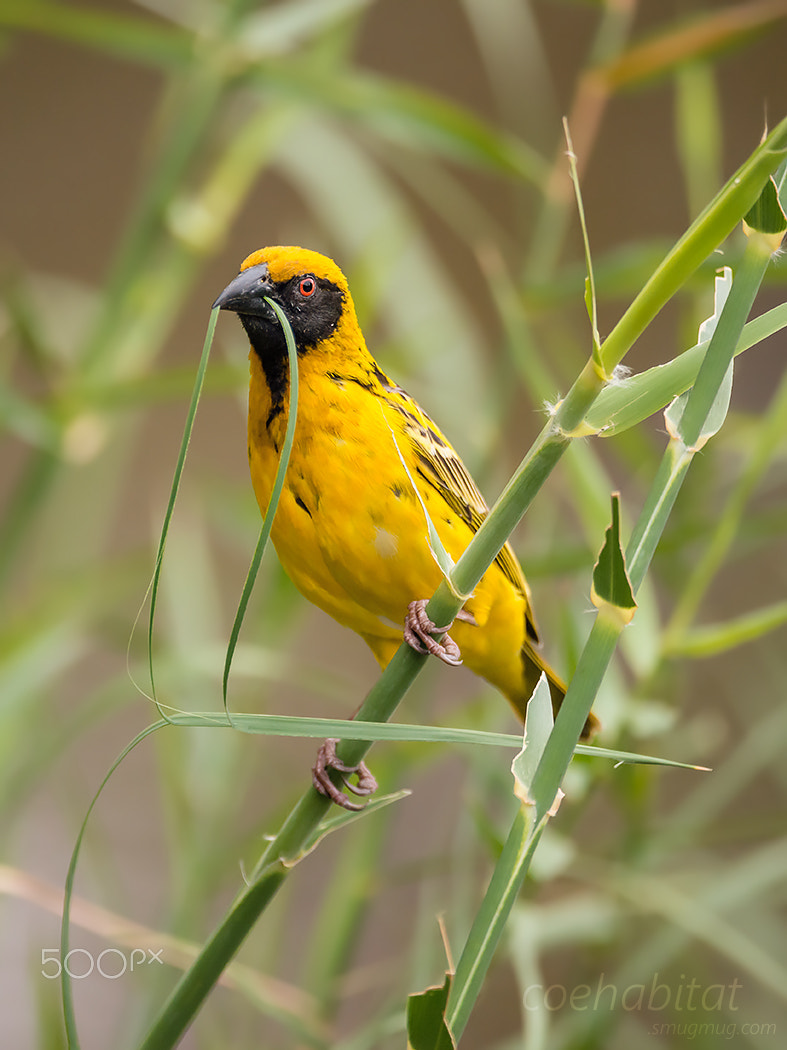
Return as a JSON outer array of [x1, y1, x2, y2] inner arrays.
[[213, 247, 357, 362]]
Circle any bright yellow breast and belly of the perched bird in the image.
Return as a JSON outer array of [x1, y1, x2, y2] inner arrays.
[[249, 361, 526, 697]]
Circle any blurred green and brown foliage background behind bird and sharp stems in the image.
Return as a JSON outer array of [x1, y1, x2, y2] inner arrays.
[[0, 0, 787, 1050]]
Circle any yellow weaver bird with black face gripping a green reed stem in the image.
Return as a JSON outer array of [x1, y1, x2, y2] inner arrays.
[[213, 246, 598, 809]]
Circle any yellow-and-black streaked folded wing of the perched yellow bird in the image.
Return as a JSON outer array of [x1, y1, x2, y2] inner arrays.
[[386, 387, 538, 644]]
